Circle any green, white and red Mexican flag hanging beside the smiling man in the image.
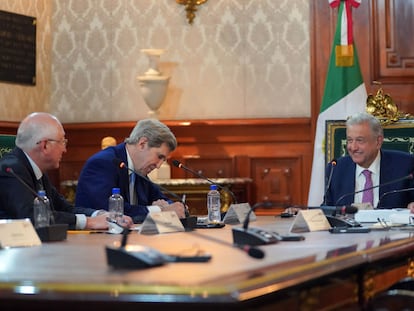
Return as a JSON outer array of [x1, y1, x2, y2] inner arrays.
[[308, 0, 367, 206]]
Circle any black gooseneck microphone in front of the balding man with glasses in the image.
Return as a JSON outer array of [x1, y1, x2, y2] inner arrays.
[[5, 167, 68, 242]]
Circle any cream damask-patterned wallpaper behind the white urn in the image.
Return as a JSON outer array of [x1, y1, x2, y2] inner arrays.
[[0, 0, 310, 123]]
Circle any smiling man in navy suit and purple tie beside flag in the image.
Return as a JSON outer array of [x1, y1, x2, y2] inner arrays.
[[325, 113, 414, 208]]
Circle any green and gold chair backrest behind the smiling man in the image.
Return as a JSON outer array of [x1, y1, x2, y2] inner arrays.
[[325, 120, 414, 164]]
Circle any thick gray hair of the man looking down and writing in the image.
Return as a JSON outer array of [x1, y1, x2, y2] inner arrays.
[[125, 119, 177, 151]]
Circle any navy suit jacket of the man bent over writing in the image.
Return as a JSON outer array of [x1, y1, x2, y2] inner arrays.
[[76, 143, 168, 222]]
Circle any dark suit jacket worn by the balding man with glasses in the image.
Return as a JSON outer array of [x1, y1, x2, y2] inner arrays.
[[0, 147, 94, 229]]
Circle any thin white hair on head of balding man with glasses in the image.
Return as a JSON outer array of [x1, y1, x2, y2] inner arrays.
[[16, 112, 60, 152]]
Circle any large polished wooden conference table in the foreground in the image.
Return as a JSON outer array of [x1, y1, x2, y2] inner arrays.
[[0, 216, 414, 310]]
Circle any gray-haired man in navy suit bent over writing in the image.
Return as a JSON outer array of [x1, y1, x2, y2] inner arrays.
[[76, 119, 185, 222]]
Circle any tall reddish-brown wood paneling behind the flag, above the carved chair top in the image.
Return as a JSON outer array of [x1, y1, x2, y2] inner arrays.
[[310, 0, 414, 135]]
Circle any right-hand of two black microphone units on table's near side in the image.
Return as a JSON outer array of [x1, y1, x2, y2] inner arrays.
[[232, 202, 282, 245]]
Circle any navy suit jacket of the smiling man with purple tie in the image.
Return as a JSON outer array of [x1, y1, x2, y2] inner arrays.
[[325, 150, 414, 208]]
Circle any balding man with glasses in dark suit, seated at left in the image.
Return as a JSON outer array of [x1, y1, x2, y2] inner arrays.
[[0, 112, 132, 229]]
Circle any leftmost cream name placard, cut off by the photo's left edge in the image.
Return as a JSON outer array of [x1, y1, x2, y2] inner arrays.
[[0, 219, 42, 248]]
